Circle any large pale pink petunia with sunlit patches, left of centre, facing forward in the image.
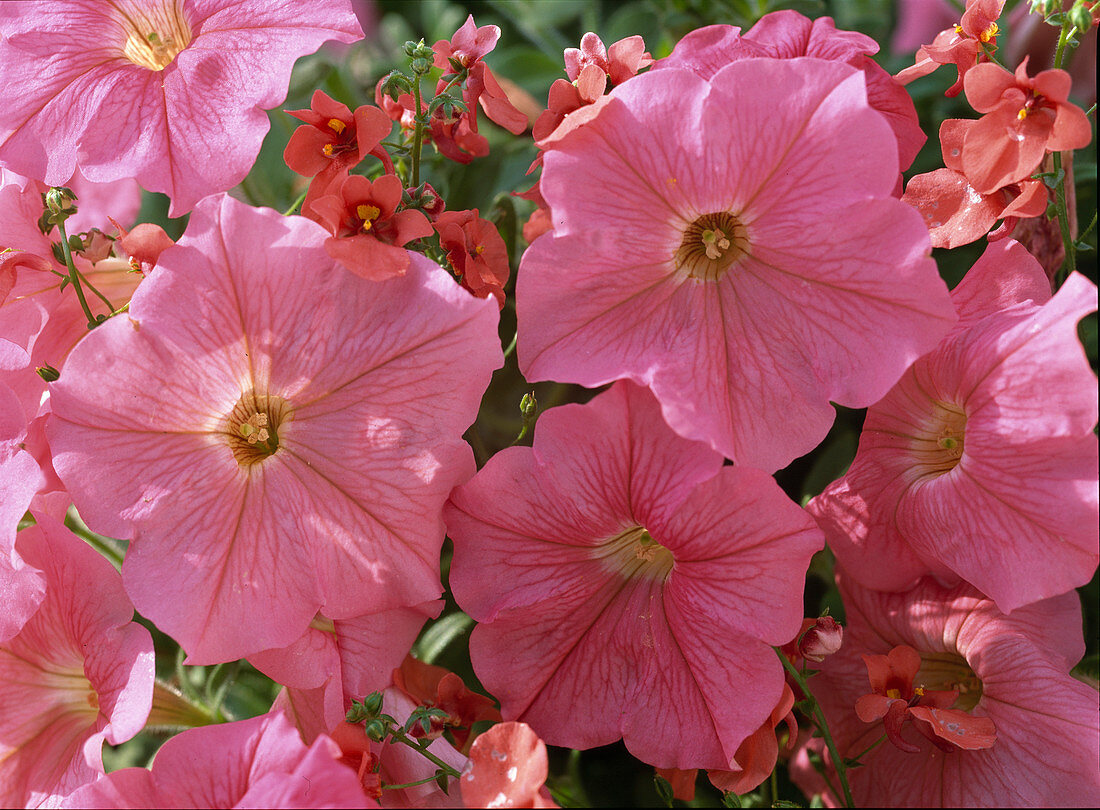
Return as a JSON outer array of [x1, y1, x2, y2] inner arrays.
[[48, 197, 502, 664]]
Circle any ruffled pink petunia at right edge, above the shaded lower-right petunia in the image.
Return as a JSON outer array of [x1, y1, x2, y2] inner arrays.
[[807, 240, 1100, 612]]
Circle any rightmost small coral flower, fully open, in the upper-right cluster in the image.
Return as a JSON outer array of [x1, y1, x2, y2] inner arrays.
[[963, 57, 1092, 193]]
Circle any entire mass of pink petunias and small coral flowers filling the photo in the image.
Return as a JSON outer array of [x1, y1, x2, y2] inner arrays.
[[0, 0, 1100, 807]]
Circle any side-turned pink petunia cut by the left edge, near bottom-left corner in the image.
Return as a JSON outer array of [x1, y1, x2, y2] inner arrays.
[[0, 514, 153, 807]]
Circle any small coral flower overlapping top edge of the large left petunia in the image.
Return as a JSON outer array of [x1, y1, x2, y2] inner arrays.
[[304, 174, 431, 281]]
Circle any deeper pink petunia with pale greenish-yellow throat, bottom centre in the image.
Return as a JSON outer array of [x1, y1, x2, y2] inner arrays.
[[446, 382, 822, 770]]
